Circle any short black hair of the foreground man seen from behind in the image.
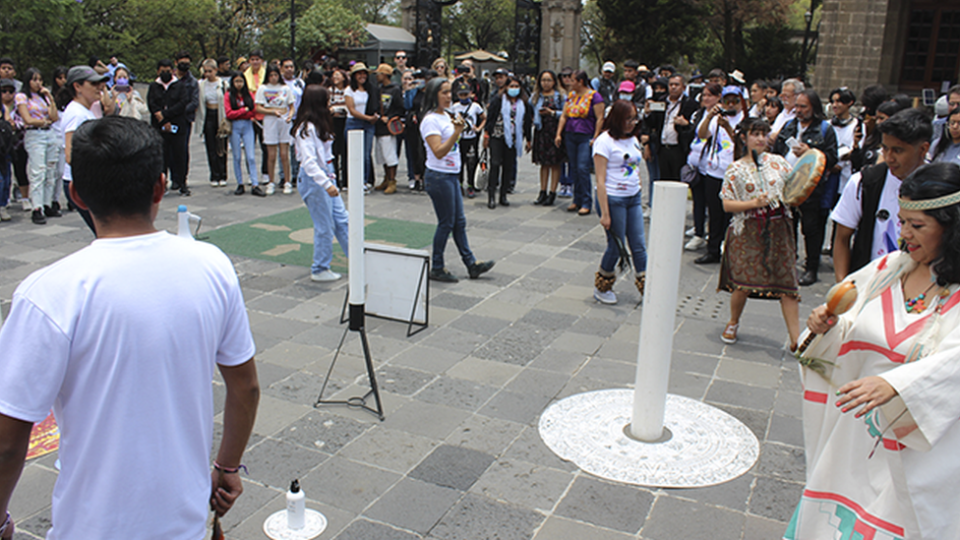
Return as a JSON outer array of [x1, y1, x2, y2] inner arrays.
[[70, 116, 163, 220]]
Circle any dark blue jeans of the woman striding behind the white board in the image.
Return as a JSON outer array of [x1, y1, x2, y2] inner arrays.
[[423, 169, 477, 270]]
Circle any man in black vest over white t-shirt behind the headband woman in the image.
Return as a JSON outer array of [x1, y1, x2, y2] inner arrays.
[[830, 109, 933, 283]]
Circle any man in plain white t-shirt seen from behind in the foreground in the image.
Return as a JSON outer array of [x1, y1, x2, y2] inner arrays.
[[0, 116, 259, 540]]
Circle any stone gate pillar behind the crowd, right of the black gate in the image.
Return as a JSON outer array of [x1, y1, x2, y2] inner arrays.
[[540, 0, 583, 73]]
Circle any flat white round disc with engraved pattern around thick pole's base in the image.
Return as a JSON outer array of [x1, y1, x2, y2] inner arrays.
[[540, 390, 760, 488]]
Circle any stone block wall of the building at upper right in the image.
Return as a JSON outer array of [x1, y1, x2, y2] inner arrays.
[[812, 0, 909, 96]]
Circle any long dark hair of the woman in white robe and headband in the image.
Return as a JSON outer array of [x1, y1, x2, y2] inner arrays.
[[900, 163, 960, 287]]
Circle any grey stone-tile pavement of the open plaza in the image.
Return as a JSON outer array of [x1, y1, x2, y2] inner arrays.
[[0, 134, 830, 540]]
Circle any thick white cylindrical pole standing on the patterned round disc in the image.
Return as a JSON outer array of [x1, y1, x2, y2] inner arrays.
[[630, 181, 687, 441]]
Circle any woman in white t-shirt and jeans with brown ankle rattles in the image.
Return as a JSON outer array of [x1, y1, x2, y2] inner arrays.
[[593, 99, 647, 304]]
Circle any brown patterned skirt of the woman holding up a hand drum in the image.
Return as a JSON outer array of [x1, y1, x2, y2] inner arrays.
[[717, 207, 800, 299]]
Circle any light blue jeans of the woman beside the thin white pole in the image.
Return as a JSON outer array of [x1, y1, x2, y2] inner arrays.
[[297, 169, 350, 274]]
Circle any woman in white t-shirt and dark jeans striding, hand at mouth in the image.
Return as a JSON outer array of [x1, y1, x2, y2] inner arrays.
[[420, 77, 493, 283]]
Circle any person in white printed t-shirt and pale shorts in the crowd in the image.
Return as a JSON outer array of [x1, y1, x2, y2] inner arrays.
[[253, 65, 294, 195]]
